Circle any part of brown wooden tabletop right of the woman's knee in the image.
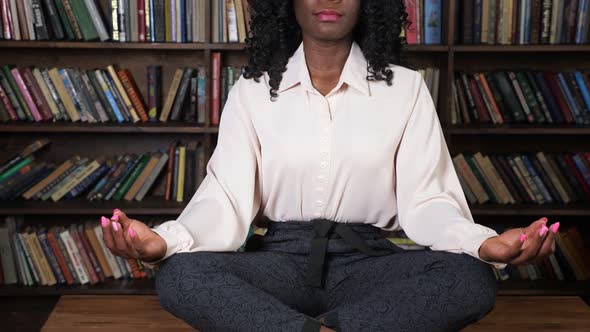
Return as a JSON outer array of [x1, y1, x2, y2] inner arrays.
[[462, 296, 590, 332]]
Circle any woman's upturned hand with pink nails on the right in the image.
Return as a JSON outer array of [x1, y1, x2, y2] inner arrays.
[[479, 218, 559, 265]]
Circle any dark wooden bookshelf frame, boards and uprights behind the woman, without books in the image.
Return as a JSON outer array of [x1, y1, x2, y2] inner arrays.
[[0, 0, 590, 296]]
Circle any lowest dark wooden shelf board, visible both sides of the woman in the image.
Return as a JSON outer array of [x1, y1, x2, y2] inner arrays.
[[0, 279, 590, 296]]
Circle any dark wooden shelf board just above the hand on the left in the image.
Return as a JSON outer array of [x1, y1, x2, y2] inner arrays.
[[0, 197, 187, 215]]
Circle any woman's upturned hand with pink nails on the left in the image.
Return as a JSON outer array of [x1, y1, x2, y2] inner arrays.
[[101, 209, 166, 263]]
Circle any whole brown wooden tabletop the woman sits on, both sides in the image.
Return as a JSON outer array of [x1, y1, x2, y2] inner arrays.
[[42, 295, 590, 332]]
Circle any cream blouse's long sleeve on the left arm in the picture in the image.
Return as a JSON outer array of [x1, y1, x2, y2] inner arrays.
[[147, 77, 261, 263]]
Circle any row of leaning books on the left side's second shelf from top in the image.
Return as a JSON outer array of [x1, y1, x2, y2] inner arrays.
[[0, 65, 158, 123]]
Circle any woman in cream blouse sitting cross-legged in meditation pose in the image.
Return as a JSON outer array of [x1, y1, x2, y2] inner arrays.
[[102, 0, 559, 331]]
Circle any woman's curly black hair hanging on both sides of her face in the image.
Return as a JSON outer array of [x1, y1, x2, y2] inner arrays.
[[243, 0, 411, 101]]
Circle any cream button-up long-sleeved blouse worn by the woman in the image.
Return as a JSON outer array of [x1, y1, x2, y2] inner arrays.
[[148, 43, 506, 268]]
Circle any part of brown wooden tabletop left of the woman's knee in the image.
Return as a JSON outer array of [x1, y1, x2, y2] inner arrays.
[[42, 295, 194, 332]]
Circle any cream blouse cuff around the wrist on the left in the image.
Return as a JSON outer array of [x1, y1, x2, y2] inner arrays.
[[141, 220, 193, 269]]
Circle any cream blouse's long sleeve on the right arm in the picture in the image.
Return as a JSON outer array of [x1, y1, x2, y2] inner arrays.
[[395, 74, 507, 268]]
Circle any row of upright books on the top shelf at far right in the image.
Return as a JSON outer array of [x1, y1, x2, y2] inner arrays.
[[457, 0, 590, 45]]
